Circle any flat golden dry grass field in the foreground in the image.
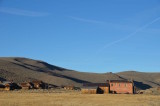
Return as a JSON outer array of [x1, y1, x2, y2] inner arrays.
[[0, 92, 160, 106]]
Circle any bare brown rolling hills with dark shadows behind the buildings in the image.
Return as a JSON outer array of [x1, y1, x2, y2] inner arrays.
[[0, 57, 160, 89]]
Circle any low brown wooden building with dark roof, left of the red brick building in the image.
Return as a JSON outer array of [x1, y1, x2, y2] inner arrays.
[[81, 83, 109, 94]]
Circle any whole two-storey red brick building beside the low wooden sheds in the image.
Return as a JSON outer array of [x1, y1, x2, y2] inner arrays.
[[109, 80, 134, 94]]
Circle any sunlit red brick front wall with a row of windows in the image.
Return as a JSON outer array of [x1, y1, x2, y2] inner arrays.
[[110, 82, 133, 94]]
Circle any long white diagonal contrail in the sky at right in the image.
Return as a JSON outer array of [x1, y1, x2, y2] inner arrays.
[[96, 17, 160, 54]]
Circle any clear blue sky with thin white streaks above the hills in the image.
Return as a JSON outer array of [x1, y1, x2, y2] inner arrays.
[[0, 0, 160, 73]]
